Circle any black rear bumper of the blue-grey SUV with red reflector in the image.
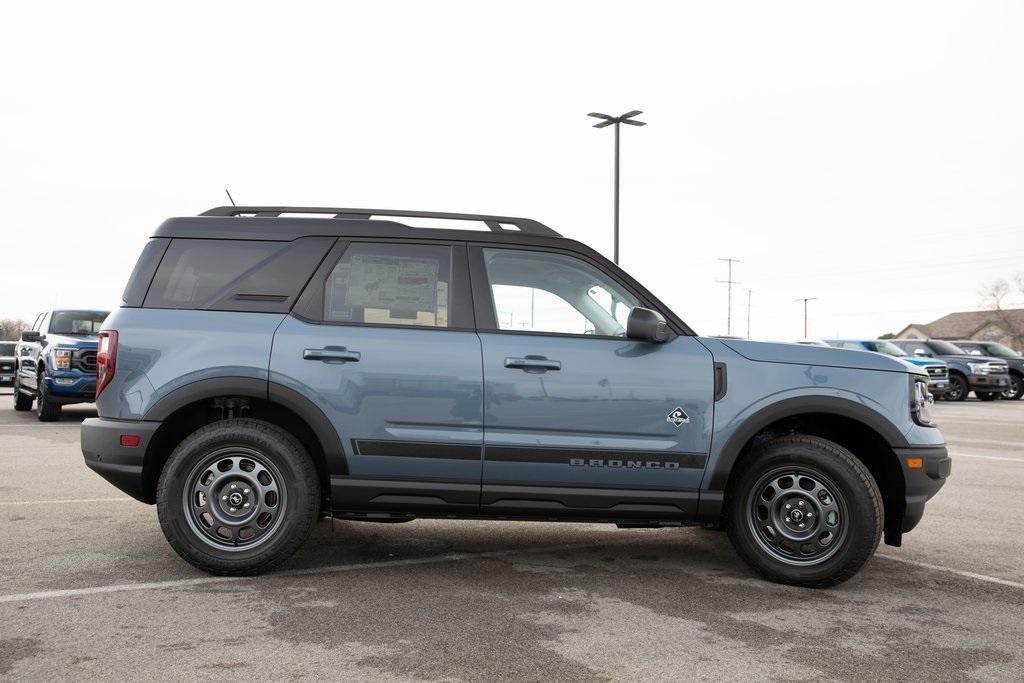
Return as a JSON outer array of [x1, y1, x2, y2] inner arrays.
[[81, 418, 162, 503]]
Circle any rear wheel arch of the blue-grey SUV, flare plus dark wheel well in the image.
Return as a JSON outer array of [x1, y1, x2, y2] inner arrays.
[[142, 377, 347, 503]]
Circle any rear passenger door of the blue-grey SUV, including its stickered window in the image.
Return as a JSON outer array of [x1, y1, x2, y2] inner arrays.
[[270, 241, 483, 513]]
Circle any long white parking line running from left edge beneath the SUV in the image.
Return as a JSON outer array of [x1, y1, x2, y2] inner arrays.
[[0, 538, 622, 603]]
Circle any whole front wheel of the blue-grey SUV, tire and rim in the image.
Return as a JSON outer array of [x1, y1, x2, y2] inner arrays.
[[725, 434, 884, 588]]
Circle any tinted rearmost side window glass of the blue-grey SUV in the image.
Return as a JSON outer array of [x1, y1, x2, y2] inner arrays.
[[145, 240, 284, 308]]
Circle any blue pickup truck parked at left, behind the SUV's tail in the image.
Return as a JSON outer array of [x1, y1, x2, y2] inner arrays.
[[14, 310, 109, 422]]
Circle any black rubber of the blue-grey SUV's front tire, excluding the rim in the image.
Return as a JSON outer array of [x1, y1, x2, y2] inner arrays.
[[726, 437, 884, 587]]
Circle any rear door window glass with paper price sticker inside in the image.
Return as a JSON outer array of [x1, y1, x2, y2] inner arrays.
[[324, 242, 452, 328]]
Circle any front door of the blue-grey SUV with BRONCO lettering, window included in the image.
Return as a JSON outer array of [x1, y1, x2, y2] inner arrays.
[[472, 248, 714, 520]]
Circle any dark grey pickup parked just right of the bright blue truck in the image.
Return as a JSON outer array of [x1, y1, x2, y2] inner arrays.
[[891, 339, 1010, 400]]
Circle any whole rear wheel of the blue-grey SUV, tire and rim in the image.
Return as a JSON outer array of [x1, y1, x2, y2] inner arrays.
[[157, 419, 321, 574]]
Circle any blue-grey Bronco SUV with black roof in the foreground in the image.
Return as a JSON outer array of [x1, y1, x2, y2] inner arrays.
[[81, 202, 950, 587]]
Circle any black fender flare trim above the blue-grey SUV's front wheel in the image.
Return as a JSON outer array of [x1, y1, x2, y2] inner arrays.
[[708, 396, 910, 490]]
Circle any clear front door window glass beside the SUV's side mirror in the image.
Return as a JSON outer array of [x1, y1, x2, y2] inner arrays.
[[483, 249, 640, 337]]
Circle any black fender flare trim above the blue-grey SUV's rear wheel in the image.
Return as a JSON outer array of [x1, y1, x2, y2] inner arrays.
[[142, 377, 348, 474]]
